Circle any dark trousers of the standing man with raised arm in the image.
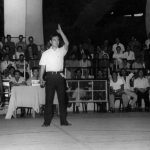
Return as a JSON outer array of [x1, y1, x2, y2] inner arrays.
[[44, 72, 67, 124]]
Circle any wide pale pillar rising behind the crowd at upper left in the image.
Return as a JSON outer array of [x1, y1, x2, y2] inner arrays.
[[4, 0, 44, 45]]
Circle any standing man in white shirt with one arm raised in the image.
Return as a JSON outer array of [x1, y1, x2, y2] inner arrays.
[[39, 24, 71, 127]]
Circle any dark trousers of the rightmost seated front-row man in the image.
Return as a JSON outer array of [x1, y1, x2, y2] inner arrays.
[[137, 91, 149, 108]]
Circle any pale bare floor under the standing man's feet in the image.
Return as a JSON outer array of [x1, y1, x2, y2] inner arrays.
[[0, 112, 150, 150]]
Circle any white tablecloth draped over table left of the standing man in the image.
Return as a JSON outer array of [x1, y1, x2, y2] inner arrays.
[[5, 86, 45, 119]]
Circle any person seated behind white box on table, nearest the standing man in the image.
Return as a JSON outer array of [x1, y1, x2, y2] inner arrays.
[[26, 67, 40, 86]]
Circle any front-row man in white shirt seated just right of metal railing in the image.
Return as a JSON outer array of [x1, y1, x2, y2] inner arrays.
[[109, 71, 127, 112]]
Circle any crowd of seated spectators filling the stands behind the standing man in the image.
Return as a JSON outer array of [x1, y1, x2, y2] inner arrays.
[[0, 31, 150, 112]]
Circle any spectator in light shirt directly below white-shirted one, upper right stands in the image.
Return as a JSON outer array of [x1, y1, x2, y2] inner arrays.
[[113, 46, 124, 69]]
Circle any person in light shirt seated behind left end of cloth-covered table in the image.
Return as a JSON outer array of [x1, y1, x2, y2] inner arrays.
[[10, 70, 26, 87]]
